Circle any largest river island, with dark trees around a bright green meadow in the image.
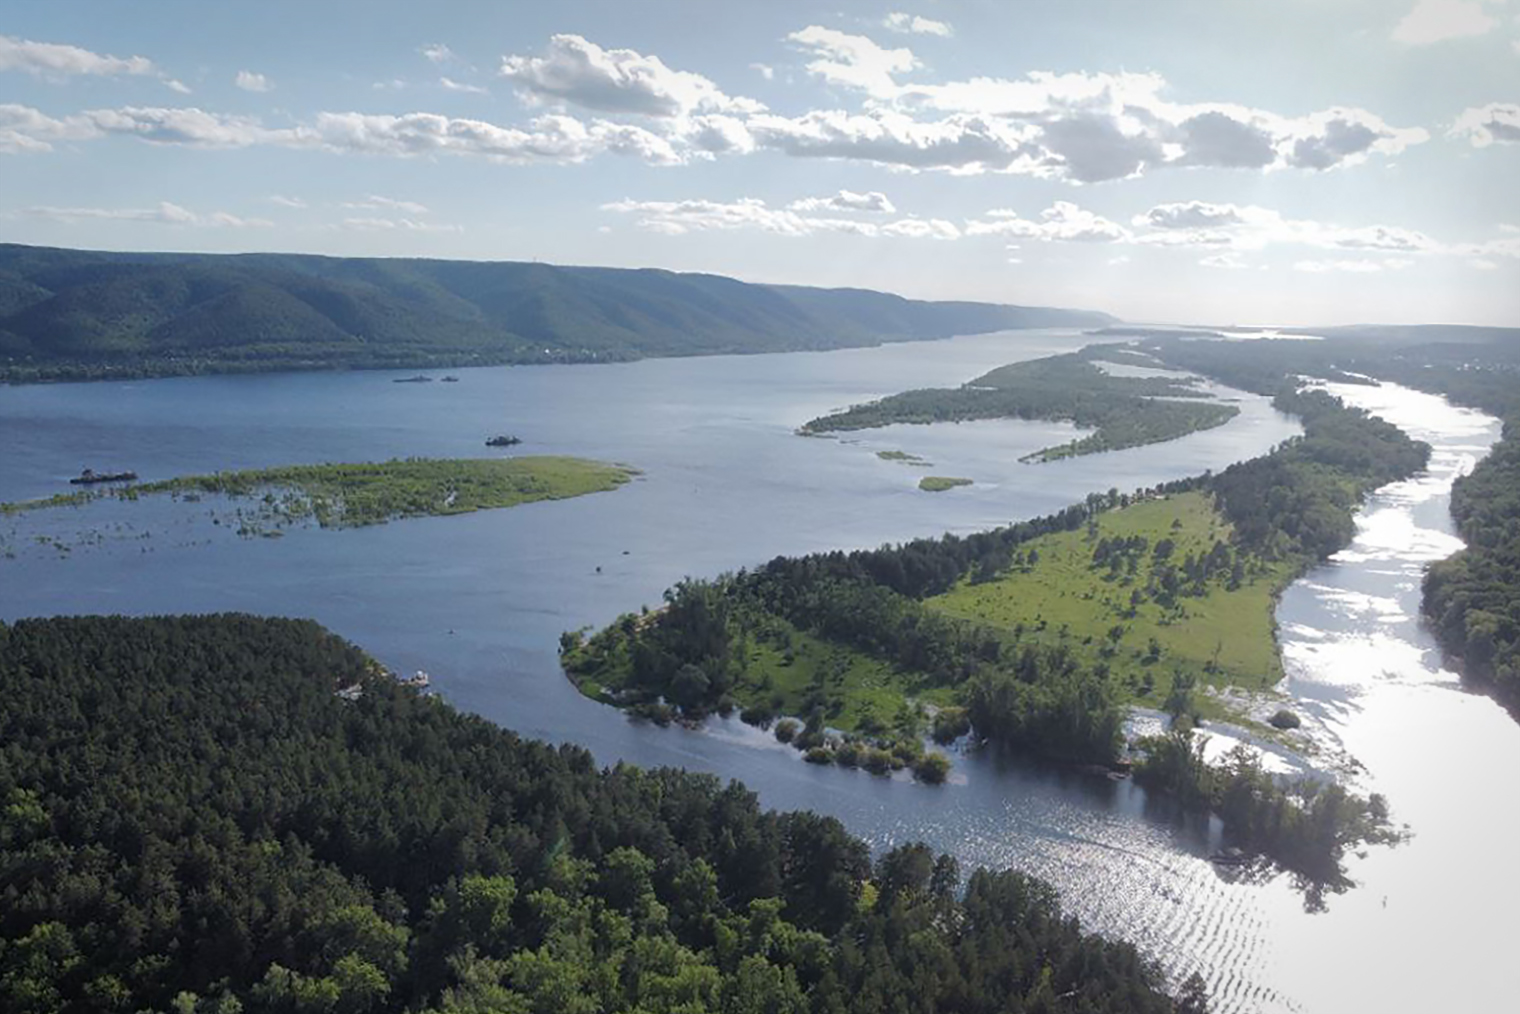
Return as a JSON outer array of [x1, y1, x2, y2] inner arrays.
[[561, 375, 1429, 888]]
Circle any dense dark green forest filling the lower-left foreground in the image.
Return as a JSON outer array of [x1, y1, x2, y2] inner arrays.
[[0, 614, 1205, 1014]]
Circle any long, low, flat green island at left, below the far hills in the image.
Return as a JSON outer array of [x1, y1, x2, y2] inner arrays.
[[0, 456, 637, 534]]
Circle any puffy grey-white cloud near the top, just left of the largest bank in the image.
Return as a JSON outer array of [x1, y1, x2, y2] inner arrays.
[[500, 35, 765, 117]]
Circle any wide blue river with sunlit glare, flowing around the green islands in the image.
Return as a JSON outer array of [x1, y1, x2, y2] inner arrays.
[[0, 331, 1520, 1014]]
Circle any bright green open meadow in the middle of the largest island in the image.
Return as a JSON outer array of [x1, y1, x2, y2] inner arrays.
[[929, 493, 1297, 705]]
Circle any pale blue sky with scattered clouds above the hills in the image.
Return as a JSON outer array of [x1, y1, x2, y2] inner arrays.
[[0, 0, 1520, 325]]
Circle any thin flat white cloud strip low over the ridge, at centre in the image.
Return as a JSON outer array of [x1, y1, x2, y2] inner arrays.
[[602, 198, 961, 239]]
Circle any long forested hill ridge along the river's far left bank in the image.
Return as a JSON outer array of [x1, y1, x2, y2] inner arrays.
[[0, 243, 1114, 382]]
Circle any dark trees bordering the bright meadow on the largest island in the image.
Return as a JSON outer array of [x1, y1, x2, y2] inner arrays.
[[561, 377, 1430, 871]]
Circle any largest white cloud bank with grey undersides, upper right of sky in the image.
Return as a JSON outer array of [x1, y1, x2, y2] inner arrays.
[[757, 65, 1429, 182]]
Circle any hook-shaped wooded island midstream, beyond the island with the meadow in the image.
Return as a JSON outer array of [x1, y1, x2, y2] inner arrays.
[[798, 345, 1240, 462]]
